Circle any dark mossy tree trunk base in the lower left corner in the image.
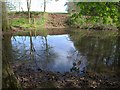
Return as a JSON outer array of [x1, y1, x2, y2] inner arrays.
[[2, 35, 21, 89]]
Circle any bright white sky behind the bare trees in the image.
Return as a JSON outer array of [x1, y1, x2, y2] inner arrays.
[[9, 0, 67, 12]]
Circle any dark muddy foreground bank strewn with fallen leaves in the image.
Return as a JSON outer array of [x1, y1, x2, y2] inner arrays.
[[13, 63, 120, 89]]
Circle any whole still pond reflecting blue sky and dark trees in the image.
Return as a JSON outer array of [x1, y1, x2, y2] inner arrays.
[[4, 31, 120, 75]]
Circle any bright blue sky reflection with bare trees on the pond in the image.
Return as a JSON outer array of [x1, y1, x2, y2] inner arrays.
[[11, 34, 85, 73]]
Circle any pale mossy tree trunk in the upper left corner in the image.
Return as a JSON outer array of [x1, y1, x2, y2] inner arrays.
[[0, 2, 10, 31]]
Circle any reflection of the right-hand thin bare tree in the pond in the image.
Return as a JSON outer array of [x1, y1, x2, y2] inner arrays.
[[41, 29, 57, 69]]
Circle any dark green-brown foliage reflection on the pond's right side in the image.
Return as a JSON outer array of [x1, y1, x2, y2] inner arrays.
[[70, 32, 120, 74]]
